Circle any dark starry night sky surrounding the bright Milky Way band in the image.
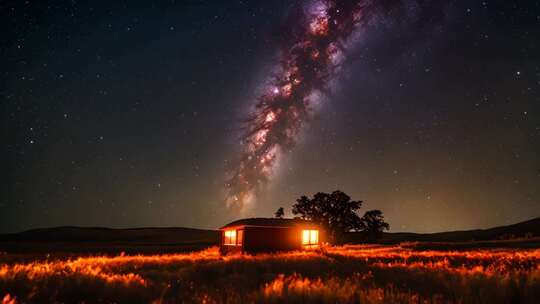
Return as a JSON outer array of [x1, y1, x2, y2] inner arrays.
[[0, 0, 540, 233]]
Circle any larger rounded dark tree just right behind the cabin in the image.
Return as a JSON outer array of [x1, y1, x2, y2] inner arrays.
[[292, 190, 364, 243]]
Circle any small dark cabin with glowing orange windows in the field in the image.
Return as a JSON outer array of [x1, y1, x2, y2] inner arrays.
[[220, 218, 324, 254]]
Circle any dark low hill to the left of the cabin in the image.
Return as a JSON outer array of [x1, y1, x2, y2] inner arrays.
[[0, 226, 220, 254]]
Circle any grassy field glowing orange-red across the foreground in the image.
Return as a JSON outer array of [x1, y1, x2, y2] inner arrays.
[[0, 246, 540, 303]]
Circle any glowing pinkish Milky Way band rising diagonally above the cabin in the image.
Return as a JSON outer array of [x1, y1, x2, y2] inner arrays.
[[227, 0, 381, 210]]
